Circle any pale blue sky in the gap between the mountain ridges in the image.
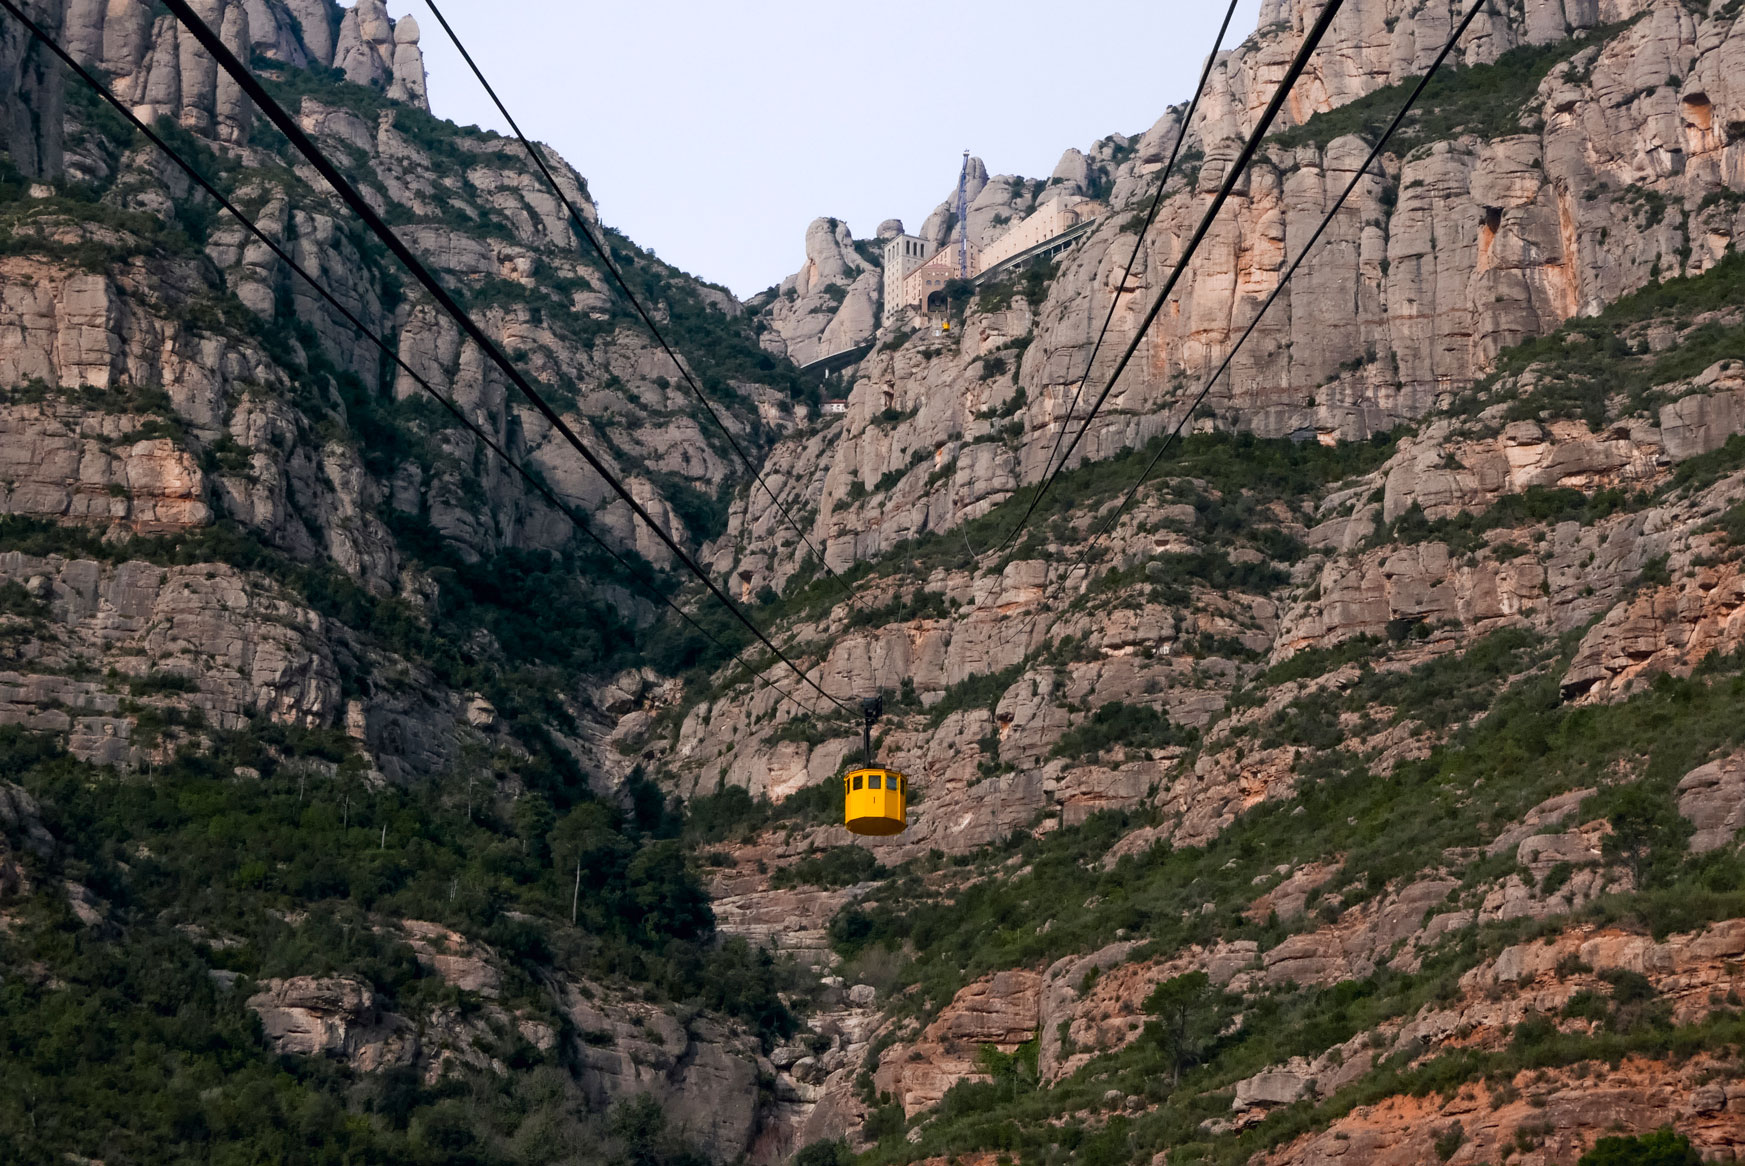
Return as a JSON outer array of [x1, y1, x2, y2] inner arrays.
[[389, 0, 1260, 297]]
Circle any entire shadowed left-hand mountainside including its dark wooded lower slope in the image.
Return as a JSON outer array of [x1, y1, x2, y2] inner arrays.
[[0, 0, 817, 1161]]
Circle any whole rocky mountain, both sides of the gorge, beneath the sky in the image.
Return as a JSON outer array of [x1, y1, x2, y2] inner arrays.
[[10, 0, 1745, 1166]]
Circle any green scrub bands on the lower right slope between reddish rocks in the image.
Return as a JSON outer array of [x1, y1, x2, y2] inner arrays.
[[832, 634, 1745, 1163]]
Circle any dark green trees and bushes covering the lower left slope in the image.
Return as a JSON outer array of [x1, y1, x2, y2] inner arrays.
[[0, 724, 794, 1166]]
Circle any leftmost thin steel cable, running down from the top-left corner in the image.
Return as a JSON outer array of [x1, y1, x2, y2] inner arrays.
[[0, 0, 815, 712]]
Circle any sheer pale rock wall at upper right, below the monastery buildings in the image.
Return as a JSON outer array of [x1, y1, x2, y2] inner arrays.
[[717, 2, 1742, 585]]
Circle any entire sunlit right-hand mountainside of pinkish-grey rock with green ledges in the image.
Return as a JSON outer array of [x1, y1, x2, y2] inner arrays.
[[614, 3, 1745, 1163]]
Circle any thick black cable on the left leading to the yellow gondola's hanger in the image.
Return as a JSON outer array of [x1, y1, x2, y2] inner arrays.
[[164, 0, 853, 712]]
